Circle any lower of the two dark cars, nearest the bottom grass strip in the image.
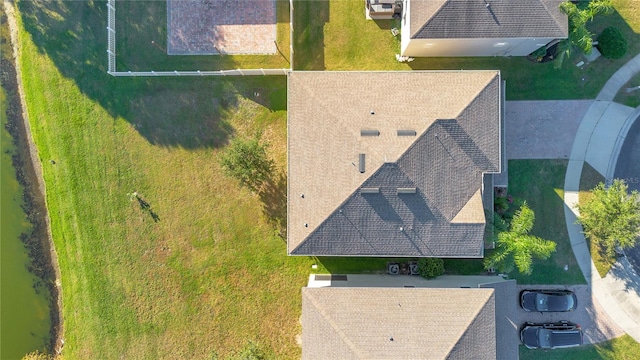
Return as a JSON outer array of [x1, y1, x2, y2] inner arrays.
[[520, 321, 582, 349]]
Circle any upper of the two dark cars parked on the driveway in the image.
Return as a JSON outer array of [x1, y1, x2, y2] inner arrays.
[[520, 289, 578, 312]]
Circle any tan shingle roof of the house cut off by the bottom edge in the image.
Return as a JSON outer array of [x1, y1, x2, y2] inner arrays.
[[302, 287, 496, 359]]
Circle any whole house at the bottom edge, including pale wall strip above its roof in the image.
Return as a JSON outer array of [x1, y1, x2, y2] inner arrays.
[[301, 274, 520, 360]]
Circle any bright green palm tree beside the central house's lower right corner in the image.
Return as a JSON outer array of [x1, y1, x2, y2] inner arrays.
[[485, 202, 556, 275]]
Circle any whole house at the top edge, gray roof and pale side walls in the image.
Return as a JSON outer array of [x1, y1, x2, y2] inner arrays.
[[401, 0, 569, 57]]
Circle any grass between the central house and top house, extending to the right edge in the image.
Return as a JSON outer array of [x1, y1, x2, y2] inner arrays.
[[293, 0, 640, 100]]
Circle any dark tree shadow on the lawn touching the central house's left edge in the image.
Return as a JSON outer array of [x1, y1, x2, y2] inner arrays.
[[259, 172, 287, 239]]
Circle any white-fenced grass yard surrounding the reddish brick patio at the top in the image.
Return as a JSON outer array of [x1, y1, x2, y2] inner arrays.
[[115, 0, 290, 71]]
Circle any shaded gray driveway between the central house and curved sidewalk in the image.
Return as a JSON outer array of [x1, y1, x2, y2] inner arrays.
[[505, 100, 593, 159]]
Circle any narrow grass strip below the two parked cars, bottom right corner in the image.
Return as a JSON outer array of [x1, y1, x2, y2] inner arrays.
[[520, 335, 640, 360]]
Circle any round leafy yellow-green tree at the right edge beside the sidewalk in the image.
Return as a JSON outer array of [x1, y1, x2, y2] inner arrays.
[[578, 179, 640, 257]]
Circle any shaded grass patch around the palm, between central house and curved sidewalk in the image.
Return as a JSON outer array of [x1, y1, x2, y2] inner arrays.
[[502, 160, 586, 284]]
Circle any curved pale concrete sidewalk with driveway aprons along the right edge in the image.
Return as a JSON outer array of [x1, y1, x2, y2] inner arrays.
[[564, 55, 640, 342]]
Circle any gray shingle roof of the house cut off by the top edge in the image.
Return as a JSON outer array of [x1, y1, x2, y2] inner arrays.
[[409, 0, 569, 39]]
